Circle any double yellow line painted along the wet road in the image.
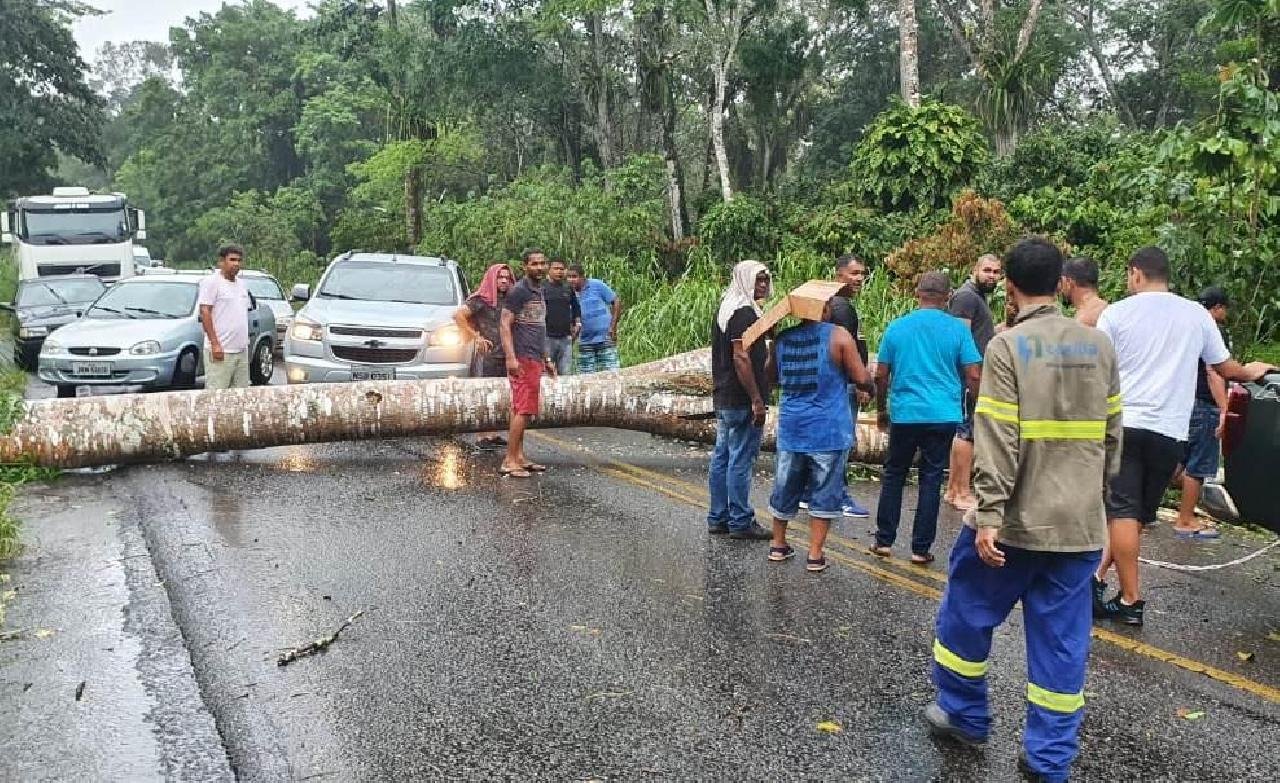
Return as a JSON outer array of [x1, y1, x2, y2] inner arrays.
[[530, 432, 1280, 704]]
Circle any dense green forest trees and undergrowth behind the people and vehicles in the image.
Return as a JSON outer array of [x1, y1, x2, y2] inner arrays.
[[0, 0, 1280, 361]]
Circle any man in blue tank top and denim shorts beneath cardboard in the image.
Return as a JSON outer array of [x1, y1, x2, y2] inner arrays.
[[769, 284, 876, 572]]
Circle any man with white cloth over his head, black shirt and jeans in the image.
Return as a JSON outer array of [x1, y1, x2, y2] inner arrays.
[[707, 261, 773, 541]]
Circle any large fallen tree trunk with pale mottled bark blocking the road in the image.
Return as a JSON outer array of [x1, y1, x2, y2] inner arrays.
[[0, 349, 883, 468]]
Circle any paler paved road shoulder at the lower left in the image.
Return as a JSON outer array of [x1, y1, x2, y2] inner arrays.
[[0, 475, 232, 780]]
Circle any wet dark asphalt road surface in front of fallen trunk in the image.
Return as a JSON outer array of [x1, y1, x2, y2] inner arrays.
[[2, 371, 1280, 780]]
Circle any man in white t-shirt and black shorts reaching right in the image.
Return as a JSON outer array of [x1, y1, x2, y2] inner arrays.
[[1093, 247, 1271, 626]]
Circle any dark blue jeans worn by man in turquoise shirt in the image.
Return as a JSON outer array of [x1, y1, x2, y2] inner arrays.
[[876, 423, 956, 555]]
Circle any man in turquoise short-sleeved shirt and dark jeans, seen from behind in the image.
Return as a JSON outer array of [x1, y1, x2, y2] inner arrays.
[[872, 273, 982, 566]]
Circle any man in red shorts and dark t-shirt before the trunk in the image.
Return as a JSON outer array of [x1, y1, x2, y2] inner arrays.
[[498, 248, 556, 479]]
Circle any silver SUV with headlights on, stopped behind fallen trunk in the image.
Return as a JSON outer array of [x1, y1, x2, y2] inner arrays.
[[284, 252, 471, 384]]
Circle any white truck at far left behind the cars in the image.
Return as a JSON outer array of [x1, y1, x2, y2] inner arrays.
[[0, 188, 147, 284]]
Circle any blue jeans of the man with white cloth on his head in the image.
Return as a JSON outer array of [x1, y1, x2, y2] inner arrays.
[[707, 408, 764, 530]]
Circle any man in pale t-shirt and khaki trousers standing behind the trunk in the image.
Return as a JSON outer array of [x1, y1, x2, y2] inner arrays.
[[200, 244, 252, 389]]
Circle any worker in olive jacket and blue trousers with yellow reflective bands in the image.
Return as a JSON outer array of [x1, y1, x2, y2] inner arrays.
[[924, 238, 1124, 783]]
